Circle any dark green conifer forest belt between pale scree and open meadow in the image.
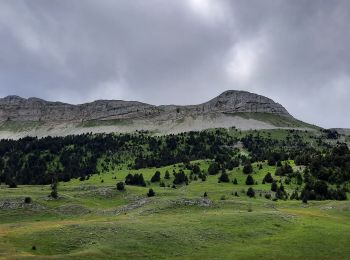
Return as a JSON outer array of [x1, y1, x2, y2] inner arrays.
[[0, 129, 350, 200]]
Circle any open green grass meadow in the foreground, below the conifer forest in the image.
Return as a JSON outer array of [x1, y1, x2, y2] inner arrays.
[[0, 161, 350, 259]]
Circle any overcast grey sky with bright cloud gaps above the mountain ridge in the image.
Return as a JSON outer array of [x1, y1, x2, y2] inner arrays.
[[0, 0, 350, 128]]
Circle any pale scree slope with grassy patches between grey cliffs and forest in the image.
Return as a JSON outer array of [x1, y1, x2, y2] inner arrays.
[[0, 113, 320, 139]]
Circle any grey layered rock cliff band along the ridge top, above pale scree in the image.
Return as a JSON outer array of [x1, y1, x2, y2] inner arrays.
[[0, 90, 291, 122]]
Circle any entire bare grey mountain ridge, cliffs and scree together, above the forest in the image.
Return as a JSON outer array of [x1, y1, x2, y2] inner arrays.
[[0, 90, 316, 138]]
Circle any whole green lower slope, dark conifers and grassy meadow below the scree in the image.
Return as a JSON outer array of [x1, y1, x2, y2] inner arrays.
[[0, 128, 350, 259]]
